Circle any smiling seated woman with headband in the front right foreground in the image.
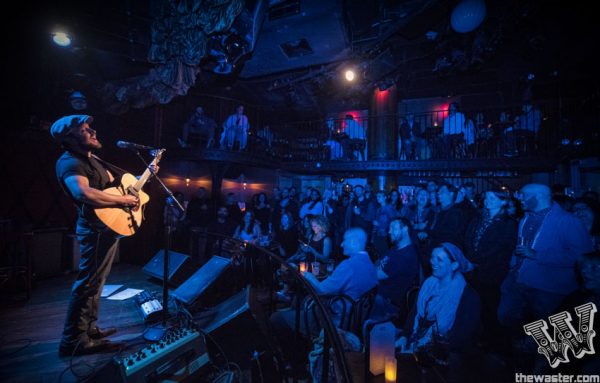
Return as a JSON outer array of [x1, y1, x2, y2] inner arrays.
[[396, 242, 481, 378]]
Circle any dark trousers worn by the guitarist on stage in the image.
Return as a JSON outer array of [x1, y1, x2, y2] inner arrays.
[[61, 226, 119, 346]]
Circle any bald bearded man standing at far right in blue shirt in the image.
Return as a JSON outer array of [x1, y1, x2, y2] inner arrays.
[[498, 184, 593, 331]]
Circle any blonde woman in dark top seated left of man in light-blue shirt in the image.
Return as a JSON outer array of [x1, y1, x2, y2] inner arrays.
[[290, 215, 332, 271]]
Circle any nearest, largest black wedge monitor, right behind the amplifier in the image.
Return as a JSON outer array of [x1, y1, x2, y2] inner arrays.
[[194, 287, 268, 370]]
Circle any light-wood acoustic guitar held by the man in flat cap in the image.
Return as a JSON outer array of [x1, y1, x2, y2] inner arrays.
[[94, 149, 165, 237]]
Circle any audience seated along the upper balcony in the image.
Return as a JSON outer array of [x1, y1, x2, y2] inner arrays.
[[178, 99, 558, 161]]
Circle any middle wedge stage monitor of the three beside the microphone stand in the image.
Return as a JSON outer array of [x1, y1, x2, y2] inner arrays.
[[171, 255, 231, 306]]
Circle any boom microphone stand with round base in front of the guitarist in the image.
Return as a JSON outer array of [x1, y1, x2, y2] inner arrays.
[[135, 150, 185, 342]]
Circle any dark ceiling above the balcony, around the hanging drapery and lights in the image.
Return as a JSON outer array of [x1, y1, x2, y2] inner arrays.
[[13, 0, 598, 118]]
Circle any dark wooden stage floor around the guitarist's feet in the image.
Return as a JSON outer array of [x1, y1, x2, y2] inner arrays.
[[0, 264, 178, 383]]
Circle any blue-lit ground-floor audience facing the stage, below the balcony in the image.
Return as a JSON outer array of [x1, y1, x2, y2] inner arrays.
[[167, 180, 600, 380]]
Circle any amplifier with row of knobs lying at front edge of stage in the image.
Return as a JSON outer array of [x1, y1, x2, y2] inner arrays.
[[114, 328, 209, 383]]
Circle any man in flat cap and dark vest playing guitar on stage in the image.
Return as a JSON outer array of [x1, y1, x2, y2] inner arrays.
[[50, 115, 158, 356]]
